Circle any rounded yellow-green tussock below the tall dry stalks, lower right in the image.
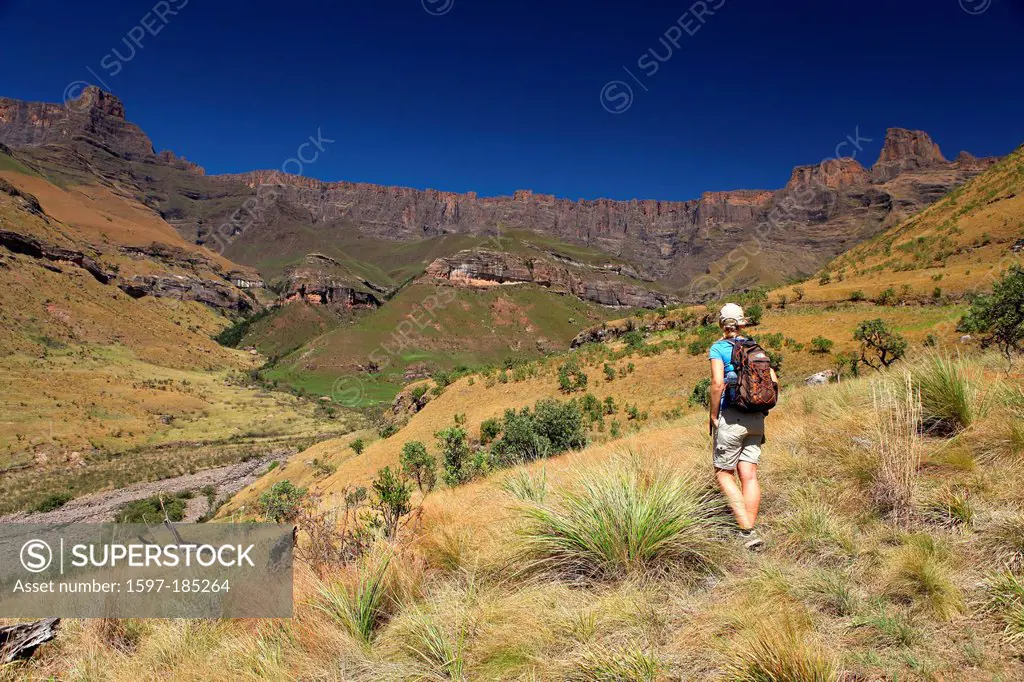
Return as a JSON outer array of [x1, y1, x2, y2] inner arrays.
[[887, 535, 964, 621]]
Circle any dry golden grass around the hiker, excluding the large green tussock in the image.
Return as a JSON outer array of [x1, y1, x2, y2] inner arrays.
[[8, 352, 1024, 680]]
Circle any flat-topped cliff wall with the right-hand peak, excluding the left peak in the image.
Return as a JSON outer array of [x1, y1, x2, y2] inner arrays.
[[200, 128, 991, 286]]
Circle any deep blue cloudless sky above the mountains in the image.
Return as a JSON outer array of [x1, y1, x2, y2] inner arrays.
[[0, 0, 1024, 200]]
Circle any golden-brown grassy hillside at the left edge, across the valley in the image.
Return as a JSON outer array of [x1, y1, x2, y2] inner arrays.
[[0, 160, 360, 514]]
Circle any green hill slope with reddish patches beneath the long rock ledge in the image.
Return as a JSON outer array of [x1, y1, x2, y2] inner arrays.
[[264, 282, 622, 403]]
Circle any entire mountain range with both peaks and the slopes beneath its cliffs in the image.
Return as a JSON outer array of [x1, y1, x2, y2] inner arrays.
[[0, 87, 995, 307]]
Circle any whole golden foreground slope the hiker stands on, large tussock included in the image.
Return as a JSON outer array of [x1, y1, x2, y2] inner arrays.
[[24, 353, 1024, 682]]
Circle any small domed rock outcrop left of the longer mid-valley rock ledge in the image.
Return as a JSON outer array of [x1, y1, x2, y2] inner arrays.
[[283, 253, 387, 309]]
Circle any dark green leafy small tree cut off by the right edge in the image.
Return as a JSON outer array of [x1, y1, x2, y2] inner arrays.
[[957, 265, 1024, 363]]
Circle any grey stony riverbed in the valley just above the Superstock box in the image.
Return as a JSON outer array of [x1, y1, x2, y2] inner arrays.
[[0, 450, 294, 523]]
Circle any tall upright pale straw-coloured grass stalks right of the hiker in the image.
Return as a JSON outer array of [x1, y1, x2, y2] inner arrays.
[[871, 375, 922, 522]]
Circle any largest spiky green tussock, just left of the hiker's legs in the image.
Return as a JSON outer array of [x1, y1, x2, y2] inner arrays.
[[522, 461, 725, 579]]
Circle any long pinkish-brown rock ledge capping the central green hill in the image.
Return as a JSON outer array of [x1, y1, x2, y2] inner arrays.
[[426, 250, 678, 308]]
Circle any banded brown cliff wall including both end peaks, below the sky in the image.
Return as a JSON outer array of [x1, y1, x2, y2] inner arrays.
[[0, 88, 993, 299]]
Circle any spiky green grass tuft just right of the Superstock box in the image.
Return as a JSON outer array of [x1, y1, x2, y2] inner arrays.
[[313, 552, 397, 644]]
